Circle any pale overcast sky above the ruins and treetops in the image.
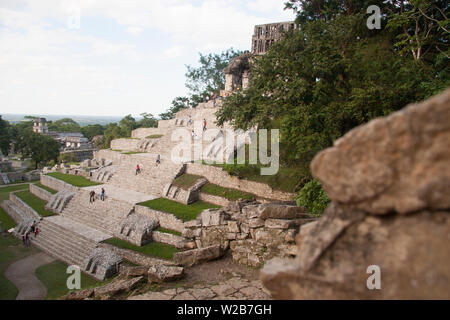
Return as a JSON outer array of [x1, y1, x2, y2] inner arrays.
[[0, 0, 294, 116]]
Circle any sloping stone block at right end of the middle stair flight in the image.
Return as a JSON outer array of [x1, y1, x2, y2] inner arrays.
[[116, 213, 159, 246]]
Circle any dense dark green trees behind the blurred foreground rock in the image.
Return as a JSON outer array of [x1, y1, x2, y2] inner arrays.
[[218, 1, 450, 164]]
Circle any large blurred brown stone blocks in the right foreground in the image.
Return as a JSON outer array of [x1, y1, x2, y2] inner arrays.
[[261, 89, 450, 299]]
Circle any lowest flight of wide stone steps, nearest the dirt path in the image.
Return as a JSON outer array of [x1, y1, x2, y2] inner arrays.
[[30, 219, 97, 269]]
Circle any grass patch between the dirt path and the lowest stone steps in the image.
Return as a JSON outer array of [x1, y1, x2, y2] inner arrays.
[[36, 261, 112, 300]]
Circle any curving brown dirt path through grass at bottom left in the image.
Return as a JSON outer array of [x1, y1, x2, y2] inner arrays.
[[4, 253, 54, 300]]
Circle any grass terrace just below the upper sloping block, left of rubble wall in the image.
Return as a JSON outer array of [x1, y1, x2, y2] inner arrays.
[[139, 198, 220, 221]]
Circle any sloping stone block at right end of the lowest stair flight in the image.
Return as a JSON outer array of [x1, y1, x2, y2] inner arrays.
[[84, 247, 122, 280]]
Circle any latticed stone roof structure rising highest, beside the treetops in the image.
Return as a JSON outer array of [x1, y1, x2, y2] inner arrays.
[[252, 21, 297, 55]]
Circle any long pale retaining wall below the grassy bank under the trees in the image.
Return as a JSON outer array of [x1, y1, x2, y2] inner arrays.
[[186, 163, 295, 201]]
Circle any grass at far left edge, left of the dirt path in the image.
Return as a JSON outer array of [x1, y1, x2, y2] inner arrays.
[[0, 235, 38, 300]]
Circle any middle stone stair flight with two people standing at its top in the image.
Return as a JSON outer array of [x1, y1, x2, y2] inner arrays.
[[61, 190, 133, 235]]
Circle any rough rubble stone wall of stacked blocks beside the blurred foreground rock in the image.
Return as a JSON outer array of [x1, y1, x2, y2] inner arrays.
[[182, 201, 316, 267]]
